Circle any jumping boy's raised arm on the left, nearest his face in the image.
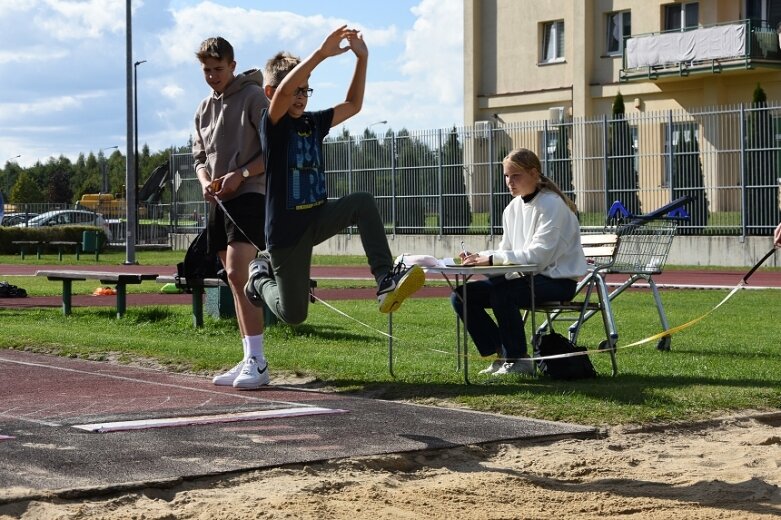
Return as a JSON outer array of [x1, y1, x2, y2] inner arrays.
[[268, 25, 357, 124]]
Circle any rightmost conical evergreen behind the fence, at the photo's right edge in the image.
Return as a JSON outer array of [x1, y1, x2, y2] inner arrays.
[[743, 83, 779, 235]]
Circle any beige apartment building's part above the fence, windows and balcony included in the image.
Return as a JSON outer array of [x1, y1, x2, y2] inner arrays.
[[464, 0, 781, 124]]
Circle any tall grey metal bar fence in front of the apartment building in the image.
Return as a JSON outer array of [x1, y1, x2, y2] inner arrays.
[[4, 103, 781, 244]]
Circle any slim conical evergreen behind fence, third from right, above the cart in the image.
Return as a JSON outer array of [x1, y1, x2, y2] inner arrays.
[[605, 92, 641, 215]]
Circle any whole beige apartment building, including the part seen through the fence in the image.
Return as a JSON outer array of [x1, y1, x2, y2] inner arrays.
[[464, 0, 781, 223]]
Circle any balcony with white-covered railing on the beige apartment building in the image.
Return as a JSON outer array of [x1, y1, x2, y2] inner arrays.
[[619, 20, 781, 82]]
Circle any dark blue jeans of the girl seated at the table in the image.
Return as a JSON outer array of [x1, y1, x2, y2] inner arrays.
[[450, 275, 577, 362]]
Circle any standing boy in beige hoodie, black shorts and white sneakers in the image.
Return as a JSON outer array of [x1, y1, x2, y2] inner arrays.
[[193, 37, 269, 389]]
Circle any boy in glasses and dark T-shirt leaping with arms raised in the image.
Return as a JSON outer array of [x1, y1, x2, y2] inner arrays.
[[244, 26, 425, 324]]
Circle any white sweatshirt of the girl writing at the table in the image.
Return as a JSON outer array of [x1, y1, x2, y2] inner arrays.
[[480, 190, 586, 280]]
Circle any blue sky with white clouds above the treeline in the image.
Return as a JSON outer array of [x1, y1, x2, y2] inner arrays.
[[0, 0, 464, 167]]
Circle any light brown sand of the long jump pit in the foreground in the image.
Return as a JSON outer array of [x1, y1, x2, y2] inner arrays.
[[0, 413, 781, 520]]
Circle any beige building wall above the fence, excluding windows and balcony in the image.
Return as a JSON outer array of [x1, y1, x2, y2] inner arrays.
[[464, 0, 781, 125]]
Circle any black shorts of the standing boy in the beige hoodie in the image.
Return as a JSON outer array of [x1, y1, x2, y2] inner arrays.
[[206, 193, 266, 253]]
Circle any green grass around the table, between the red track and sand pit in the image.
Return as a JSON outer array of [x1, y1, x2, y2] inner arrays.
[[0, 284, 781, 425]]
